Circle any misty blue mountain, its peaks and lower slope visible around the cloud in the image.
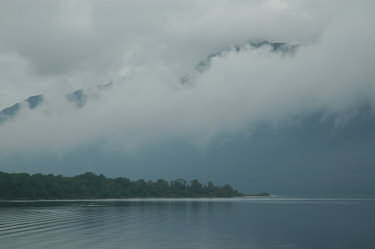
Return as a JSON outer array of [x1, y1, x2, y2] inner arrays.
[[0, 41, 375, 197]]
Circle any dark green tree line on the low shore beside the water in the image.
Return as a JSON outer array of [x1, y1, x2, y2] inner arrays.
[[0, 172, 260, 200]]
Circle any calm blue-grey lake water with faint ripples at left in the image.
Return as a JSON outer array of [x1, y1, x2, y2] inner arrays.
[[0, 198, 375, 249]]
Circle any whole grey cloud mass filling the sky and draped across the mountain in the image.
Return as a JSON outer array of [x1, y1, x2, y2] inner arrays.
[[0, 1, 375, 153]]
